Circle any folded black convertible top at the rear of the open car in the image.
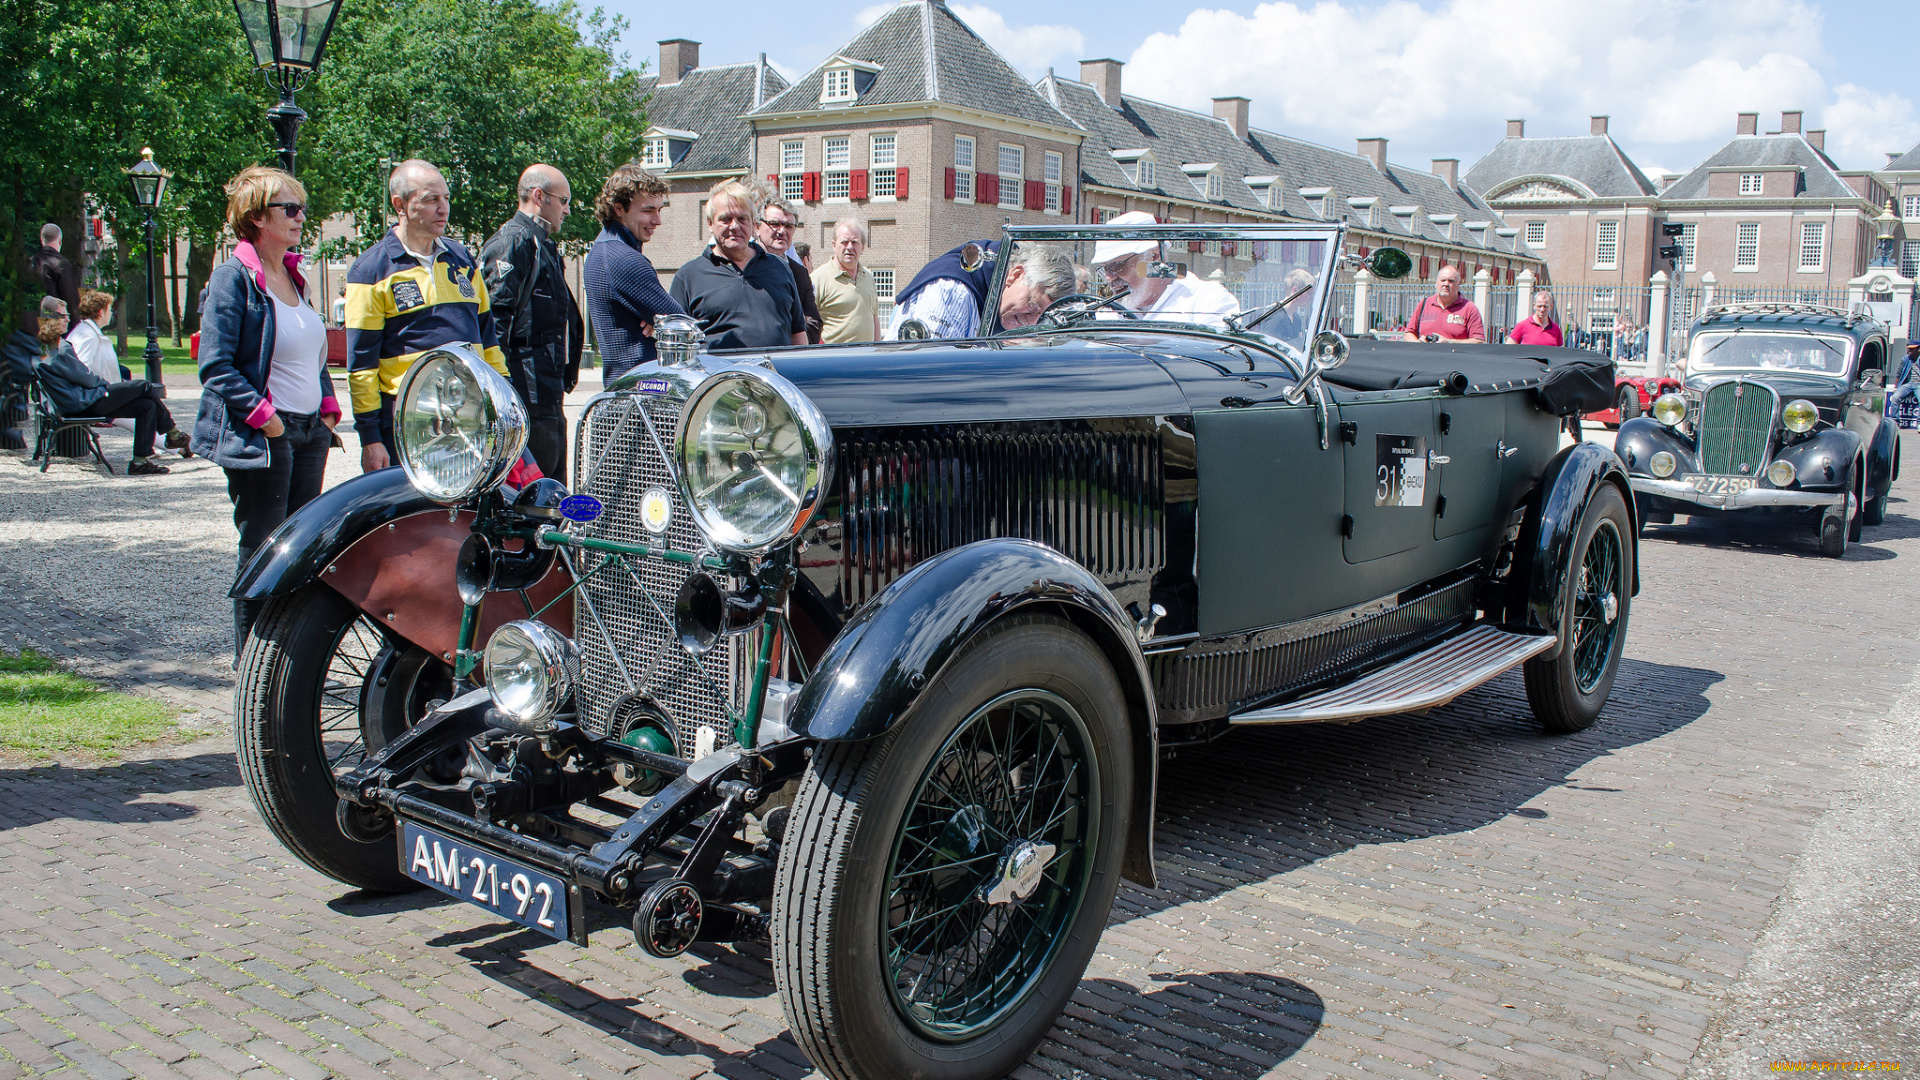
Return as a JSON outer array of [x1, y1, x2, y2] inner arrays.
[[1327, 338, 1613, 417]]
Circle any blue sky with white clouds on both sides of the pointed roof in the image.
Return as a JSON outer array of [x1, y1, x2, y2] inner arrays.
[[605, 0, 1920, 177]]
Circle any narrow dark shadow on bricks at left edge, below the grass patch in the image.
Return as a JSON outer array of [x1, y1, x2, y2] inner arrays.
[[0, 753, 240, 832]]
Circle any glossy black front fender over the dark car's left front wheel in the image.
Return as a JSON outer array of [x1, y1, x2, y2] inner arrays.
[[230, 469, 440, 600]]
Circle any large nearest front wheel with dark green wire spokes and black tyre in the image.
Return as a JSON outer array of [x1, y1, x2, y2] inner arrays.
[[774, 615, 1133, 1080]]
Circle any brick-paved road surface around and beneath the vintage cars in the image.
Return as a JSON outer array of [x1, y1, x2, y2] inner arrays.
[[0, 407, 1920, 1080]]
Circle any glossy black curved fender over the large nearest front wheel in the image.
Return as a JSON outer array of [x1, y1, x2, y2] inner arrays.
[[793, 538, 1160, 886]]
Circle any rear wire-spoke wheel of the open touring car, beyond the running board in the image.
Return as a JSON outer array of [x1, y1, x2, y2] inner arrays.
[[1523, 484, 1636, 732]]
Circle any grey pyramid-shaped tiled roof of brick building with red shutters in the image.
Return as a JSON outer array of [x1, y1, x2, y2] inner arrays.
[[755, 0, 1071, 127]]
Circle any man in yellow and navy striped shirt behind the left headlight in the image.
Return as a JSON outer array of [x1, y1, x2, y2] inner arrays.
[[348, 158, 511, 473]]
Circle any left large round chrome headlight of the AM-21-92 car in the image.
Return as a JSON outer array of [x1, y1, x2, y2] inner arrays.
[[394, 346, 526, 503]]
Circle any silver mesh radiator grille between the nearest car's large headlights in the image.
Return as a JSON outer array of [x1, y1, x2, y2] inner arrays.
[[574, 394, 745, 757]]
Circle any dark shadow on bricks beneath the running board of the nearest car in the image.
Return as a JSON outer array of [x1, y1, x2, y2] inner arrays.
[[1114, 659, 1722, 920]]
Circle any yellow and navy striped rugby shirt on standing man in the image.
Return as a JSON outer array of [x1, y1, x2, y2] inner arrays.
[[348, 233, 507, 444]]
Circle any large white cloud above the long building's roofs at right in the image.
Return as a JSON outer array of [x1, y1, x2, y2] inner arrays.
[[1121, 0, 1896, 167]]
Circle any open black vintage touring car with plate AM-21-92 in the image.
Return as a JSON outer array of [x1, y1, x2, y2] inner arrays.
[[236, 225, 1638, 1080]]
